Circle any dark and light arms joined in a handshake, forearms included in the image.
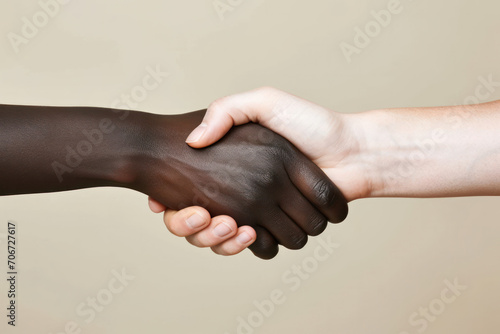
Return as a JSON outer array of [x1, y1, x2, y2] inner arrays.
[[0, 88, 490, 259]]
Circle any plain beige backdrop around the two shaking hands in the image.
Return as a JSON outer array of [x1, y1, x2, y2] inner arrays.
[[0, 0, 500, 334]]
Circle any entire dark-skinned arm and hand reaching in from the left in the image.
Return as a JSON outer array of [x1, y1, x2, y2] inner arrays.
[[0, 105, 347, 259]]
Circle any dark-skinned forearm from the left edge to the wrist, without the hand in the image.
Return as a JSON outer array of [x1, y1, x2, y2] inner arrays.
[[0, 105, 154, 195]]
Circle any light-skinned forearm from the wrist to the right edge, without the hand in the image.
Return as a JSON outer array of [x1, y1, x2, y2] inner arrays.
[[345, 101, 500, 197]]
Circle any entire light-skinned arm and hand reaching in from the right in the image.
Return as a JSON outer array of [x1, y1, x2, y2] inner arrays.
[[155, 87, 500, 255]]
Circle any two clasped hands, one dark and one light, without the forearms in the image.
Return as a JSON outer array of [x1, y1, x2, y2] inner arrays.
[[141, 88, 354, 259]]
